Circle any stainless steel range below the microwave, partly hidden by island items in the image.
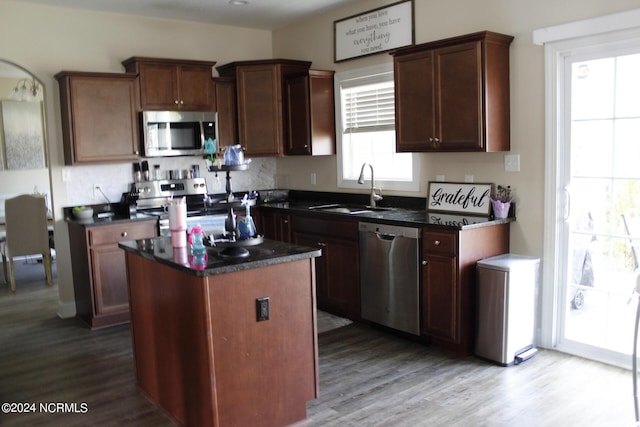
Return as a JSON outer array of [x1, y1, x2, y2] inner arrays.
[[129, 178, 227, 236]]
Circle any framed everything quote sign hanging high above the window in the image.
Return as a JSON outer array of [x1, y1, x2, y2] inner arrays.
[[333, 0, 415, 62]]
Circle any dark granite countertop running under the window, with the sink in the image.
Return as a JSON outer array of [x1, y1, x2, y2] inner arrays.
[[259, 200, 515, 230]]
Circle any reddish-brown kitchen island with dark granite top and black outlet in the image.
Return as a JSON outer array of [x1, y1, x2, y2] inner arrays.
[[119, 237, 321, 427]]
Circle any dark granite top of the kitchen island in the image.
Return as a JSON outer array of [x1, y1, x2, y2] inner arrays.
[[118, 237, 322, 277]]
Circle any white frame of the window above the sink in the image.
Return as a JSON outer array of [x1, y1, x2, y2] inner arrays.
[[334, 62, 420, 192]]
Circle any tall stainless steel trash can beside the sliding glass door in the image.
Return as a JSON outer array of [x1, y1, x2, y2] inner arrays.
[[475, 254, 540, 366]]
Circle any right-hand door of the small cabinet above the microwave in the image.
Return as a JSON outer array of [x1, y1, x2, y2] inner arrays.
[[178, 65, 215, 111]]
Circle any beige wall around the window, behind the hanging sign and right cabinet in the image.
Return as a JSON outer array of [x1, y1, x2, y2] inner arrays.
[[273, 0, 638, 257]]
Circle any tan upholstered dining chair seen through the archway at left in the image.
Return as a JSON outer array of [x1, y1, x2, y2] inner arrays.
[[0, 194, 52, 292]]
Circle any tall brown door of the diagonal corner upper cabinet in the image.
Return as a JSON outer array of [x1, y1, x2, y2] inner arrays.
[[236, 65, 283, 156]]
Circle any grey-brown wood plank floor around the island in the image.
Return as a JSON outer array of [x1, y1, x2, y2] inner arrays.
[[0, 265, 635, 427]]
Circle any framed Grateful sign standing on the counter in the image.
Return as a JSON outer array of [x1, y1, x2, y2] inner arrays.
[[427, 182, 493, 215]]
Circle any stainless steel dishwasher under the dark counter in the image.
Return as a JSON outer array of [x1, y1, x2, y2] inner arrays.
[[358, 222, 420, 335]]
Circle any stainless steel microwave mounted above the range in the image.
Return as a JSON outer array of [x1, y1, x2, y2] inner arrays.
[[142, 111, 218, 157]]
